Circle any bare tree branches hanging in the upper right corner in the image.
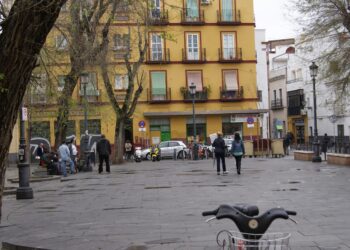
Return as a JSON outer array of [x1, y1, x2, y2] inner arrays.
[[292, 0, 350, 93]]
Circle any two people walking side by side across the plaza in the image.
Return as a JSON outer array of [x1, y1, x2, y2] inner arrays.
[[212, 132, 245, 175]]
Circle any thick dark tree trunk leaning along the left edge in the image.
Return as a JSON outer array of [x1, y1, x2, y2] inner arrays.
[[0, 0, 66, 222]]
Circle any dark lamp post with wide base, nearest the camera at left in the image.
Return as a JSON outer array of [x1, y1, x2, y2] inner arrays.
[[16, 104, 33, 200]]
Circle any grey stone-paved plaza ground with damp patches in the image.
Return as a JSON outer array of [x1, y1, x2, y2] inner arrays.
[[0, 156, 350, 250]]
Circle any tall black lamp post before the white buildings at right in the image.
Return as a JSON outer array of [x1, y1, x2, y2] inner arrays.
[[309, 62, 322, 162]]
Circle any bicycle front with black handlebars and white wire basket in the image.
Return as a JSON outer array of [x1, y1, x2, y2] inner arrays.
[[202, 204, 297, 250]]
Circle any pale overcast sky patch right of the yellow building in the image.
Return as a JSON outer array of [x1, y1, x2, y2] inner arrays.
[[254, 0, 296, 40]]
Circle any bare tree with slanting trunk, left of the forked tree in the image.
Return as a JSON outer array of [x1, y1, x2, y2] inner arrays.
[[55, 0, 117, 147]]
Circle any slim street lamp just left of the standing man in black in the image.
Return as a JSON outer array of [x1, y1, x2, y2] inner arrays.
[[80, 73, 92, 172]]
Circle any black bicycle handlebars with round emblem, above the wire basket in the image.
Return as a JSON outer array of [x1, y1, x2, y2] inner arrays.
[[202, 205, 297, 237]]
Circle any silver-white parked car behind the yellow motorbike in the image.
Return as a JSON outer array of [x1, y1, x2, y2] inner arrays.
[[141, 141, 189, 160]]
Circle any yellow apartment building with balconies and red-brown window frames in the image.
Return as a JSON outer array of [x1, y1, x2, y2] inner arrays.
[[28, 0, 265, 145]]
